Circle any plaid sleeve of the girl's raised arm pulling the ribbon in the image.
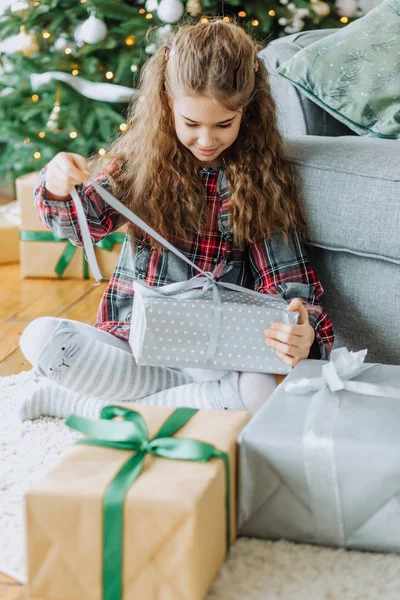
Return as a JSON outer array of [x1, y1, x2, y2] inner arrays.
[[34, 166, 124, 246]]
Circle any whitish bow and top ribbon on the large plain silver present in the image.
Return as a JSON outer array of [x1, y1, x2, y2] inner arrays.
[[285, 347, 400, 398]]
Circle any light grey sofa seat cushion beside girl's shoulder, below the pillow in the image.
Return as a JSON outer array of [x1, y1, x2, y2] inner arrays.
[[286, 136, 400, 264]]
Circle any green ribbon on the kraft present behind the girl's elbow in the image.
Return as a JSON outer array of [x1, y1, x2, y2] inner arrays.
[[20, 231, 125, 279]]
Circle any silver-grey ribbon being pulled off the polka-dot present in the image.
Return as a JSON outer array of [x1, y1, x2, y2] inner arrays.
[[71, 179, 299, 365]]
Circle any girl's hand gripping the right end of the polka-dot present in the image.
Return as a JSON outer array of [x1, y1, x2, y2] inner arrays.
[[264, 298, 315, 367]]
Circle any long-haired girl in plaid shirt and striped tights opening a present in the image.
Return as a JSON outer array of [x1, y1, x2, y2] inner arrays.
[[21, 19, 333, 418]]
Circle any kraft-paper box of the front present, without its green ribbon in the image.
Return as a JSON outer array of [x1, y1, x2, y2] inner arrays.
[[26, 404, 250, 600]]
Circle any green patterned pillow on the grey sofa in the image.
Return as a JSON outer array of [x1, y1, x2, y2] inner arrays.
[[278, 0, 400, 139]]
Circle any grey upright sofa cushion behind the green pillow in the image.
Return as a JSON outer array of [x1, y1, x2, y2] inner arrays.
[[259, 29, 355, 136]]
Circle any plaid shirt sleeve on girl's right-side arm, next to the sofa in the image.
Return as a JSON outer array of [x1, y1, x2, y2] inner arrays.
[[249, 233, 334, 360]]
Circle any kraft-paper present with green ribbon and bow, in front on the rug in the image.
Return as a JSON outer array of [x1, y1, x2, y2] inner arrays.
[[26, 404, 250, 600]]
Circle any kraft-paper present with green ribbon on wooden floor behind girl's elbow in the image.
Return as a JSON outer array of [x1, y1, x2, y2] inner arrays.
[[16, 173, 126, 279]]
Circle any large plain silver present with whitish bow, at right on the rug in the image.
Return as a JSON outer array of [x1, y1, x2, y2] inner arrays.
[[239, 348, 400, 552]]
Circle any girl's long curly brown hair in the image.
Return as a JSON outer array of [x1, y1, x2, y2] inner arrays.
[[92, 19, 305, 245]]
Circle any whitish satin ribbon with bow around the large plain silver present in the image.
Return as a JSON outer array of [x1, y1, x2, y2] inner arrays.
[[283, 347, 400, 546]]
